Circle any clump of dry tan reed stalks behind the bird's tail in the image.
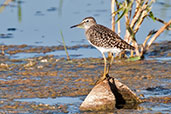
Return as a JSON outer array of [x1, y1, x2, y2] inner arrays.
[[108, 0, 171, 59]]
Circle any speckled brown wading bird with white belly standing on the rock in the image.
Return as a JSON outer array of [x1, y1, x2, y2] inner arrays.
[[70, 17, 135, 80]]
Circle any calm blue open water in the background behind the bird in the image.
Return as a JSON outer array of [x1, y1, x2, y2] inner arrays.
[[0, 0, 171, 46]]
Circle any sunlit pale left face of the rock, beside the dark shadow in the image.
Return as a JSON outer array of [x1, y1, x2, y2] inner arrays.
[[80, 80, 115, 110]]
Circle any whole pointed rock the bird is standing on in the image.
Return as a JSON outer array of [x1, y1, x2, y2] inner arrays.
[[80, 77, 141, 111]]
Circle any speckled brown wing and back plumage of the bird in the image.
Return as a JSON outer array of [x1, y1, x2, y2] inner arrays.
[[85, 24, 134, 50]]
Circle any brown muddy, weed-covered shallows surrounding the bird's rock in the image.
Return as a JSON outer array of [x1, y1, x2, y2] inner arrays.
[[0, 42, 171, 114]]
